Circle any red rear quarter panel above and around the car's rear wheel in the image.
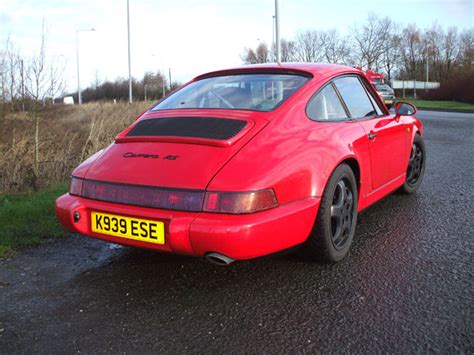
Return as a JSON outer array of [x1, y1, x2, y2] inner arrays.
[[208, 91, 370, 204]]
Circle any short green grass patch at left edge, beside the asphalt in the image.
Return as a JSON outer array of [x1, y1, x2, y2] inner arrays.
[[0, 183, 68, 258]]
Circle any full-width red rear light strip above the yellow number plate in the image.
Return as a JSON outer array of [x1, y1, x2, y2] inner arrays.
[[69, 177, 278, 214]]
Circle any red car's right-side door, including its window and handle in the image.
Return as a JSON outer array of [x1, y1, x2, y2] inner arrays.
[[334, 75, 407, 190]]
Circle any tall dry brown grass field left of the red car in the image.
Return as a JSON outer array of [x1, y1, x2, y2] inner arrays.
[[0, 102, 150, 193]]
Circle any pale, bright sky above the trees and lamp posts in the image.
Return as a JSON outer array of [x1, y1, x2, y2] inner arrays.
[[0, 0, 474, 91]]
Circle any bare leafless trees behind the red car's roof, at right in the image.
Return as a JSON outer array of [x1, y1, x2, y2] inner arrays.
[[241, 14, 474, 82]]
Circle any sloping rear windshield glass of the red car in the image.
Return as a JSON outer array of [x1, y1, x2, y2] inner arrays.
[[152, 74, 309, 111]]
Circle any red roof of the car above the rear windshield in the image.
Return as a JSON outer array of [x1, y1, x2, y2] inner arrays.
[[194, 63, 363, 80]]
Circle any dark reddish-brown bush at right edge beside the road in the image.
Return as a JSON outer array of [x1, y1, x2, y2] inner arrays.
[[421, 71, 474, 104]]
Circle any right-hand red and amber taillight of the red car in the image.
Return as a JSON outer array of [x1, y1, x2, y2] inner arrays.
[[203, 189, 278, 214]]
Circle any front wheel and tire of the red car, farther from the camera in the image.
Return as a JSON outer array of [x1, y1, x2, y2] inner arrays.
[[399, 134, 426, 194]]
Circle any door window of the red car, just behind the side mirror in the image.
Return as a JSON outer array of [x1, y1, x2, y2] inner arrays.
[[334, 76, 377, 118]]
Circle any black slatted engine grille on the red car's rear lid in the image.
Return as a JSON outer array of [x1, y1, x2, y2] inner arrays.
[[127, 117, 247, 140]]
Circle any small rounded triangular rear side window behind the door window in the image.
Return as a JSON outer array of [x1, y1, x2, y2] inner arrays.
[[306, 84, 348, 121]]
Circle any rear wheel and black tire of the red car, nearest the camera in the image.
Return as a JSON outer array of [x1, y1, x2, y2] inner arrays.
[[305, 164, 358, 263]]
